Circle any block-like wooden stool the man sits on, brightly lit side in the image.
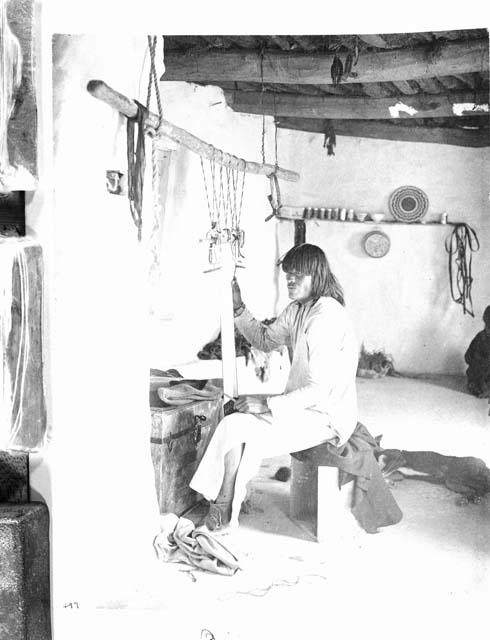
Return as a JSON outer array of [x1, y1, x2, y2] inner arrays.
[[289, 457, 362, 544]]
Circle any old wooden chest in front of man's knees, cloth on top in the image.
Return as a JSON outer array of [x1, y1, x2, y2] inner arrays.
[[151, 398, 222, 516]]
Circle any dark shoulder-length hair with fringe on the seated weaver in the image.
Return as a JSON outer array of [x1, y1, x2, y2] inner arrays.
[[279, 243, 345, 305]]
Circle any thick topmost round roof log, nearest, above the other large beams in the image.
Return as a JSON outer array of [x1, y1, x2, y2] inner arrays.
[[161, 39, 488, 84]]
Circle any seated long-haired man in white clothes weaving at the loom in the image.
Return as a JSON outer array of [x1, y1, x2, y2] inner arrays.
[[190, 244, 358, 531]]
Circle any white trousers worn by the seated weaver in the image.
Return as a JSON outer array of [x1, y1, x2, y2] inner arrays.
[[190, 409, 335, 525]]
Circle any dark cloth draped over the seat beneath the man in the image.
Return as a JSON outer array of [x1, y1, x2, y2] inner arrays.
[[291, 422, 403, 533]]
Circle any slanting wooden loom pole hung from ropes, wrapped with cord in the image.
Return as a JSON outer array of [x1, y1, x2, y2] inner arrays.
[[87, 80, 299, 182]]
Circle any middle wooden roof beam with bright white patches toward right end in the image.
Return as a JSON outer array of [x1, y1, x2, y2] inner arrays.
[[224, 91, 488, 120]]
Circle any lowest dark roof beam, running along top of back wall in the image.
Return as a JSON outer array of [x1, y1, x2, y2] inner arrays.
[[276, 118, 490, 147]]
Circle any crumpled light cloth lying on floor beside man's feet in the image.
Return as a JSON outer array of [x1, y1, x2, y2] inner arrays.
[[153, 513, 240, 576]]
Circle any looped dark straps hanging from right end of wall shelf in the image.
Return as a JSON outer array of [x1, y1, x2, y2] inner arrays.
[[446, 223, 480, 318]]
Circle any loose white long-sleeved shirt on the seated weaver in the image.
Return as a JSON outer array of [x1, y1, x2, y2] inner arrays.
[[235, 297, 358, 443]]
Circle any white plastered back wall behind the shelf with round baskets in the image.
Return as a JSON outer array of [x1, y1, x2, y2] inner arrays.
[[280, 131, 490, 373]]
